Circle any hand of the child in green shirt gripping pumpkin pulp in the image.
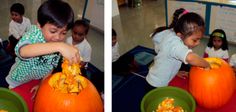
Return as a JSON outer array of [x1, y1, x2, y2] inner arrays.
[[60, 44, 80, 64]]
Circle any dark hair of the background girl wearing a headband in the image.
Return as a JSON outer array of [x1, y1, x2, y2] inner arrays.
[[207, 29, 228, 50]]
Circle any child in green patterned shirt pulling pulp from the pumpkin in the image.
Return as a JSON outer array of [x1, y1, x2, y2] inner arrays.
[[6, 0, 80, 96]]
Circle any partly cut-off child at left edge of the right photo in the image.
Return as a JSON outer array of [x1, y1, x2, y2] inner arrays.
[[112, 29, 120, 62]]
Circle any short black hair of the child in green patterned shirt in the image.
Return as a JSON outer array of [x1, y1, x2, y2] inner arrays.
[[38, 0, 74, 30]]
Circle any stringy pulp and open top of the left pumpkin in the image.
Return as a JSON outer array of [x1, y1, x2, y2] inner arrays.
[[48, 60, 87, 94]]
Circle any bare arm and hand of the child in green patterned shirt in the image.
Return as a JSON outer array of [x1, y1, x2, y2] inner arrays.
[[19, 42, 80, 63]]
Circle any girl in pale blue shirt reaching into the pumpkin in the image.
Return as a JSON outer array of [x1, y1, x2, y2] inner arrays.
[[145, 12, 210, 91]]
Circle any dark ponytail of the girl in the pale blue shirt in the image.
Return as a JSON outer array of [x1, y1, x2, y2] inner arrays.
[[152, 8, 185, 37]]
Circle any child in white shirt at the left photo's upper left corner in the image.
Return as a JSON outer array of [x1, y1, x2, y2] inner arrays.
[[7, 3, 31, 56]]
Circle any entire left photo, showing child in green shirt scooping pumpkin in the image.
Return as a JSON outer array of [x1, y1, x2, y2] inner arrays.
[[0, 0, 105, 112]]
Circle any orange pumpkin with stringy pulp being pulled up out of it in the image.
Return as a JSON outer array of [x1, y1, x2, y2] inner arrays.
[[34, 61, 103, 112]]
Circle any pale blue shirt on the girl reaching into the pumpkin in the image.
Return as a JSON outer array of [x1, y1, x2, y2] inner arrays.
[[146, 30, 192, 87]]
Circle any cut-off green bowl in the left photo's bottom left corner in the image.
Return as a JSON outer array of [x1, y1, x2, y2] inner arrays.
[[0, 87, 28, 112]]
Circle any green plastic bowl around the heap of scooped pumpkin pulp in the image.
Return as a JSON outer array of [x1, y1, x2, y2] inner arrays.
[[141, 86, 196, 112]]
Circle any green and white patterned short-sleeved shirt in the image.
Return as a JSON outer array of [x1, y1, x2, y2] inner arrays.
[[9, 25, 60, 82]]
